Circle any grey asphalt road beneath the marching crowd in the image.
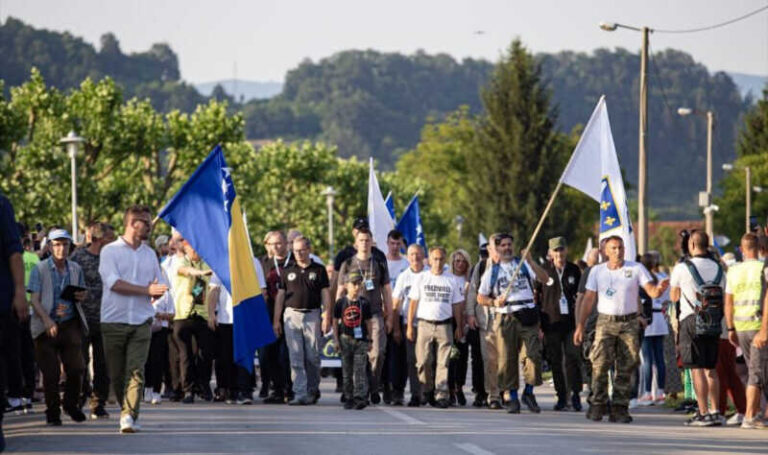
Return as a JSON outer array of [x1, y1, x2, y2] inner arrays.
[[5, 380, 768, 455]]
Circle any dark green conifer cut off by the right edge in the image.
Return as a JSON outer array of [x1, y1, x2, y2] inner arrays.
[[715, 88, 768, 246]]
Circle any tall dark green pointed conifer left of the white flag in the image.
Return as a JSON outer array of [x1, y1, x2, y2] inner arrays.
[[459, 40, 596, 251]]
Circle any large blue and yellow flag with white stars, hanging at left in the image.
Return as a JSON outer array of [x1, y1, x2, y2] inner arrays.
[[159, 146, 275, 371]]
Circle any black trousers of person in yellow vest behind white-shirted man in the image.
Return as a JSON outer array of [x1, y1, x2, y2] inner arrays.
[[173, 316, 215, 395]]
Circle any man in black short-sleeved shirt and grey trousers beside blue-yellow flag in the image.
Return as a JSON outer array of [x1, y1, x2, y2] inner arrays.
[[273, 237, 331, 405]]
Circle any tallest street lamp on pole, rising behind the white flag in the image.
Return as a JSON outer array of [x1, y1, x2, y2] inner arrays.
[[600, 22, 653, 254]]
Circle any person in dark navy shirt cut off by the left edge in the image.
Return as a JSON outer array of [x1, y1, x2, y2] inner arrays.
[[0, 192, 29, 452]]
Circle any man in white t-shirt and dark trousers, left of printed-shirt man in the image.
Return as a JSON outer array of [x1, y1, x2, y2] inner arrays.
[[389, 243, 429, 407]]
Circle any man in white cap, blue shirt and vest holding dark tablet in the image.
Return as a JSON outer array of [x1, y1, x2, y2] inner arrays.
[[29, 229, 88, 426]]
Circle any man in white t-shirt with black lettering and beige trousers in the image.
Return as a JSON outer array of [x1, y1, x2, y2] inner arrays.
[[406, 247, 464, 408]]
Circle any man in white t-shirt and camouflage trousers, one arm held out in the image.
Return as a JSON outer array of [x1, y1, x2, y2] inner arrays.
[[573, 236, 669, 423]]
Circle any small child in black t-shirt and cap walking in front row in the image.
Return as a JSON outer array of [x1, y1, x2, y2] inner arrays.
[[333, 272, 373, 409]]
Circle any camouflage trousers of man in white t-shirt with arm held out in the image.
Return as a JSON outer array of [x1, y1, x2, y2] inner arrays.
[[590, 314, 640, 407]]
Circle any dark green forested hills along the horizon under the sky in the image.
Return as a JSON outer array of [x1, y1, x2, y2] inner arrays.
[[0, 18, 749, 219]]
